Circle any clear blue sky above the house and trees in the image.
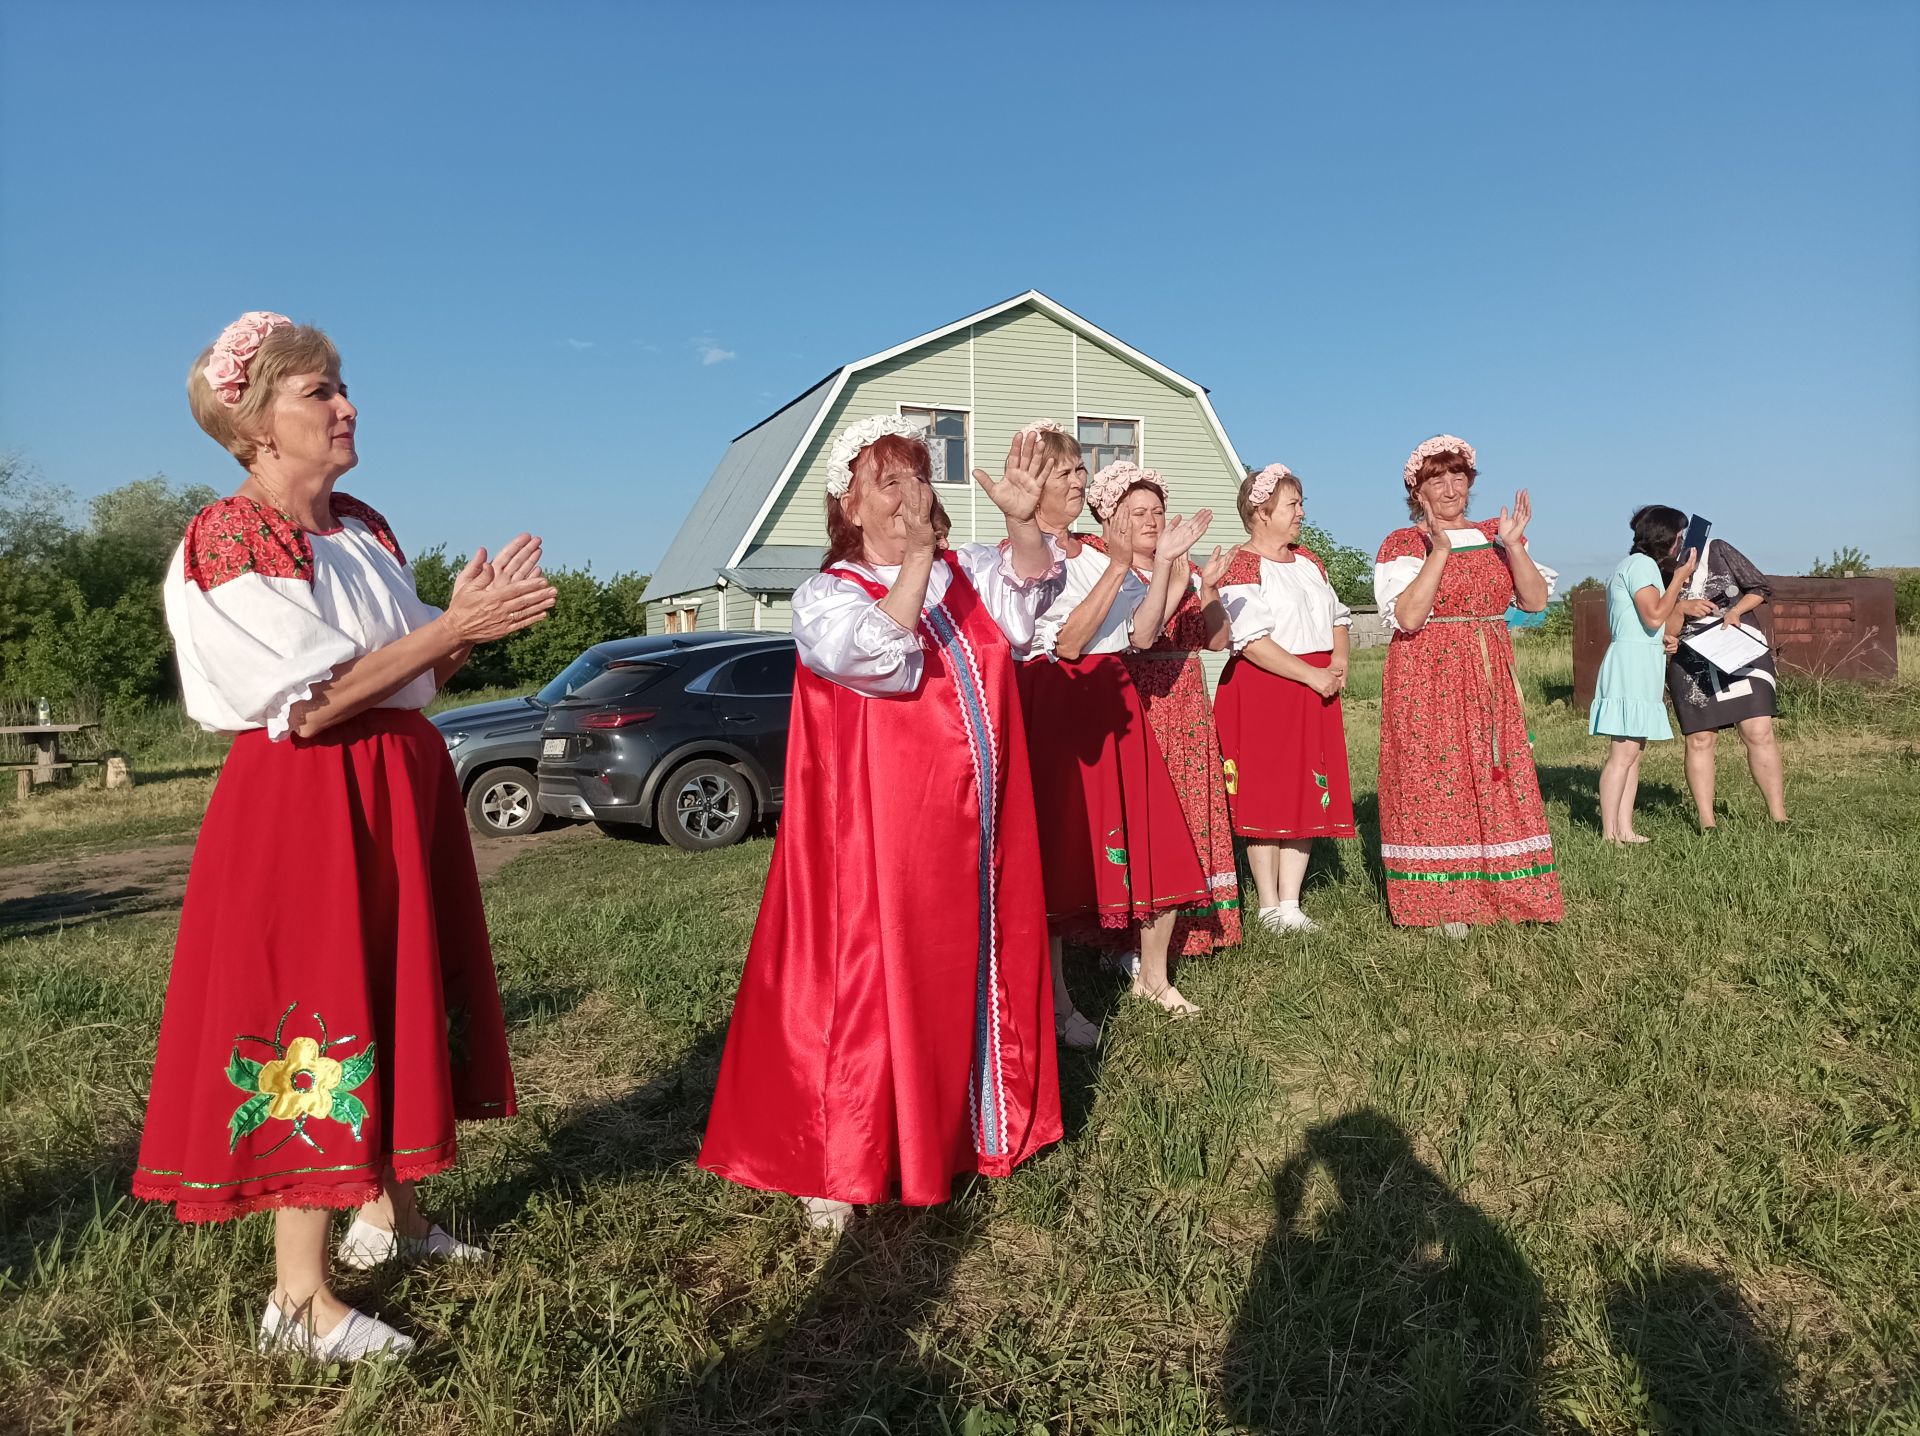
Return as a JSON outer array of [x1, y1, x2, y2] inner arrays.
[[0, 0, 1920, 574]]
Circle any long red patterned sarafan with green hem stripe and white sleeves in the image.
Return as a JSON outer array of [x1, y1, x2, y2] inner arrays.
[[1375, 518, 1561, 927]]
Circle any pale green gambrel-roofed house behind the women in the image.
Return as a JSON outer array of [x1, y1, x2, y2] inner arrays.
[[647, 290, 1244, 634]]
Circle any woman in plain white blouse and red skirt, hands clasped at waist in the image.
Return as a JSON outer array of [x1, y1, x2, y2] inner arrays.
[[1213, 465, 1354, 933]]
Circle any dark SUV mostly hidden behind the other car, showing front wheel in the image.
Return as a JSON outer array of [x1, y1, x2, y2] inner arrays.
[[430, 637, 659, 837]]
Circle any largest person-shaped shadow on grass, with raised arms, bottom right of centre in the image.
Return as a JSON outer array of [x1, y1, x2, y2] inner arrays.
[[1221, 1110, 1542, 1434]]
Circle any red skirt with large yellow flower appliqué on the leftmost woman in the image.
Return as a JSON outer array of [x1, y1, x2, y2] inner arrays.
[[132, 708, 515, 1221]]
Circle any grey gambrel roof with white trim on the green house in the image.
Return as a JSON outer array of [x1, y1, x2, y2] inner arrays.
[[647, 290, 1240, 601]]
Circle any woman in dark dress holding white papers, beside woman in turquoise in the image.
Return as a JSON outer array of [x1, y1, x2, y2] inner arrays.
[[1667, 539, 1788, 831]]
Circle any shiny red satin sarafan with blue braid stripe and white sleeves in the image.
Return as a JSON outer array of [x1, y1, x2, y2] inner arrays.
[[701, 545, 1060, 1206]]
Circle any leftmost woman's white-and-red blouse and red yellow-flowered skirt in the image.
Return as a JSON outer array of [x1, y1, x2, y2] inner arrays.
[[132, 493, 515, 1221]]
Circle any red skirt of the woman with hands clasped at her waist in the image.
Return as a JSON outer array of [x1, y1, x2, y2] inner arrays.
[[1213, 653, 1354, 843]]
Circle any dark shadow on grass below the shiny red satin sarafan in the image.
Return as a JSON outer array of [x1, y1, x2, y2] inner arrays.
[[618, 1186, 991, 1436]]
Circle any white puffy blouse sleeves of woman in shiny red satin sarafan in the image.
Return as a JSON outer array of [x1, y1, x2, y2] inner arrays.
[[793, 538, 1064, 699]]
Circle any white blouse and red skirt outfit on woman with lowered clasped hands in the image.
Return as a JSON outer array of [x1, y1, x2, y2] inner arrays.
[[1213, 543, 1354, 843]]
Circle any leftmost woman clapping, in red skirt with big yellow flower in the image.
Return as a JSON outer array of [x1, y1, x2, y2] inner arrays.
[[132, 311, 555, 1361]]
